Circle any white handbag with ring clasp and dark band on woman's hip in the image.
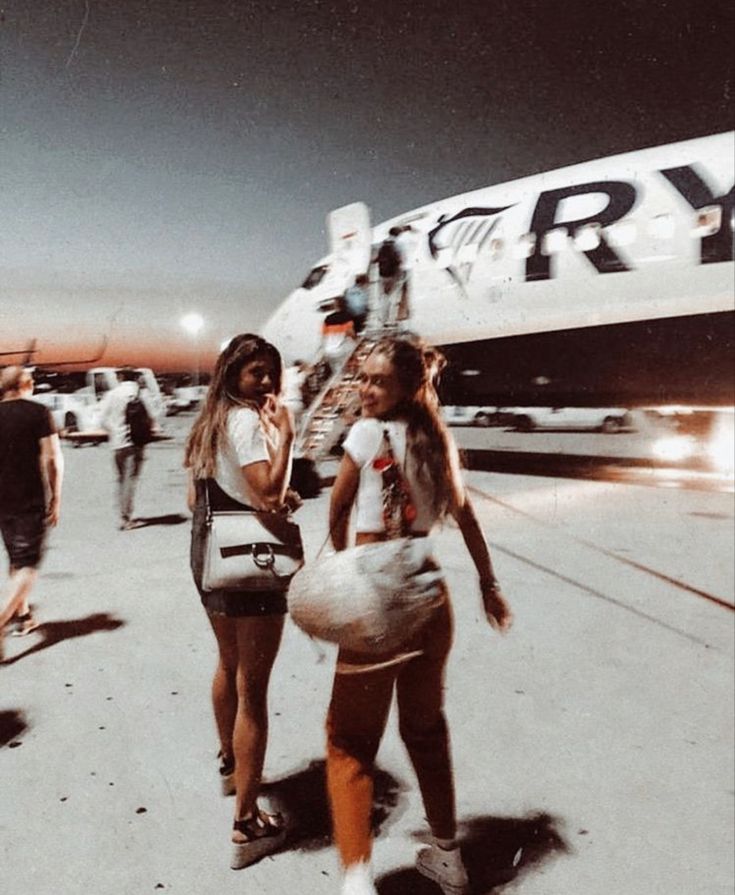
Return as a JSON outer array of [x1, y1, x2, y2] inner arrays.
[[201, 489, 304, 591]]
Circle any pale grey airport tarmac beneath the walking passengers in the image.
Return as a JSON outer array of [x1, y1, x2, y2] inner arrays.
[[0, 416, 735, 895]]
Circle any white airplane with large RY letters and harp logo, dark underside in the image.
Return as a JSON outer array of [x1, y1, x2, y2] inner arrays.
[[261, 131, 735, 408]]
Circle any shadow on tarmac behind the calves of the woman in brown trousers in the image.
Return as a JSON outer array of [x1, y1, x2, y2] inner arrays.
[[262, 760, 403, 851]]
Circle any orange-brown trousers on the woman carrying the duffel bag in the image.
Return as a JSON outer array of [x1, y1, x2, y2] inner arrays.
[[327, 598, 456, 866]]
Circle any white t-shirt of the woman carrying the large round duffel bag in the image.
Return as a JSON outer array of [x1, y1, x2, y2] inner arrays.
[[342, 417, 437, 532]]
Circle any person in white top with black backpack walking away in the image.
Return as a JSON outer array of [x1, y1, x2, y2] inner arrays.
[[100, 368, 152, 531]]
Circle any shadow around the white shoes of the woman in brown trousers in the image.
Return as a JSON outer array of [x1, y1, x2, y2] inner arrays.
[[376, 814, 569, 895]]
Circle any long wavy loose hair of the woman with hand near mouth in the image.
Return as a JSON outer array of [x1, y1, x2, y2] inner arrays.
[[184, 333, 283, 479]]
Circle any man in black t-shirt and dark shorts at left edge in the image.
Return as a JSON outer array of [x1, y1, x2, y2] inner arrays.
[[0, 367, 64, 660]]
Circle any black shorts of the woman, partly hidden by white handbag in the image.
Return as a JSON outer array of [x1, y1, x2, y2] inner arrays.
[[190, 479, 288, 618]]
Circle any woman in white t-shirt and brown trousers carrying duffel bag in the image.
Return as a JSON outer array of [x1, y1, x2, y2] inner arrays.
[[327, 336, 512, 895]]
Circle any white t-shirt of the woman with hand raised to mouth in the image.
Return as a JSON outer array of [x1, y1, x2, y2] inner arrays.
[[214, 407, 290, 509]]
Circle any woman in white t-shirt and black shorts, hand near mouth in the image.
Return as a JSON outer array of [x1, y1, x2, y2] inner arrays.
[[184, 333, 294, 869]]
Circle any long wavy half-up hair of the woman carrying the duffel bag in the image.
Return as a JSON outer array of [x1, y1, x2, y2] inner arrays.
[[371, 333, 464, 516]]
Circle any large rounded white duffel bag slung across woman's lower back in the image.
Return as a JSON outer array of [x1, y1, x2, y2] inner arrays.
[[288, 538, 445, 654]]
